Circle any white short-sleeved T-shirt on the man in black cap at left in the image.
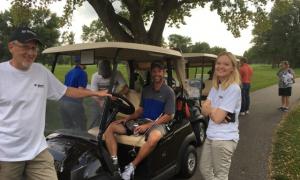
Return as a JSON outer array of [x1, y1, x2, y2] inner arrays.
[[0, 62, 67, 161]]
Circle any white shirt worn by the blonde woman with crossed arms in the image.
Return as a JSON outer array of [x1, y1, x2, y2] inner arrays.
[[206, 84, 241, 142]]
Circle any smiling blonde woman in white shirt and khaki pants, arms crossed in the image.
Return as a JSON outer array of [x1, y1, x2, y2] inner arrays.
[[200, 52, 241, 180]]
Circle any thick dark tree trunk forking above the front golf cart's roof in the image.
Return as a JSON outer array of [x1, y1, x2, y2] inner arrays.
[[88, 0, 173, 46]]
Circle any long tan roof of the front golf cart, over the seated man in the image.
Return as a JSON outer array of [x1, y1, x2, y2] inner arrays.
[[43, 42, 185, 88]]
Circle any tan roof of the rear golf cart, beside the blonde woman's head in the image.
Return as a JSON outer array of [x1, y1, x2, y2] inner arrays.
[[183, 53, 218, 67]]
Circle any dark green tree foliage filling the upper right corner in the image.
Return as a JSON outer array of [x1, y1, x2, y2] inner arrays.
[[245, 0, 300, 67]]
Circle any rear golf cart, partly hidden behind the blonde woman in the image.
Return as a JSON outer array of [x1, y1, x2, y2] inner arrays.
[[183, 53, 217, 144]]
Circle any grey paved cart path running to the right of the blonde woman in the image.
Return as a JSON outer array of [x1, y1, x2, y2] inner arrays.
[[178, 79, 300, 180]]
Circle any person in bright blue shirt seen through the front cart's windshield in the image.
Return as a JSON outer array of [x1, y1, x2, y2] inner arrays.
[[60, 56, 88, 131]]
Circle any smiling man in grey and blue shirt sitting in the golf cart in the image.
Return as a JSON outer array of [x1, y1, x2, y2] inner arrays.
[[104, 61, 175, 180]]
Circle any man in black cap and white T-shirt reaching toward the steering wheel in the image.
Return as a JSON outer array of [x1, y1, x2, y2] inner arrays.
[[0, 27, 111, 180]]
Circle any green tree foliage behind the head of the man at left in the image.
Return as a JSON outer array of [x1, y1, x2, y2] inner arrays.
[[0, 4, 61, 63]]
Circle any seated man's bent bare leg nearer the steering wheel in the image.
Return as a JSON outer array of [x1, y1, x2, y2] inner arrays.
[[104, 123, 126, 156]]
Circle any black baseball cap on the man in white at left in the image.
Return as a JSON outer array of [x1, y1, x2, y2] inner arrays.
[[9, 27, 43, 45]]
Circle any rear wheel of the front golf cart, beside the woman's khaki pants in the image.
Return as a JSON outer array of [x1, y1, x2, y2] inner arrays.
[[180, 145, 198, 178]]
